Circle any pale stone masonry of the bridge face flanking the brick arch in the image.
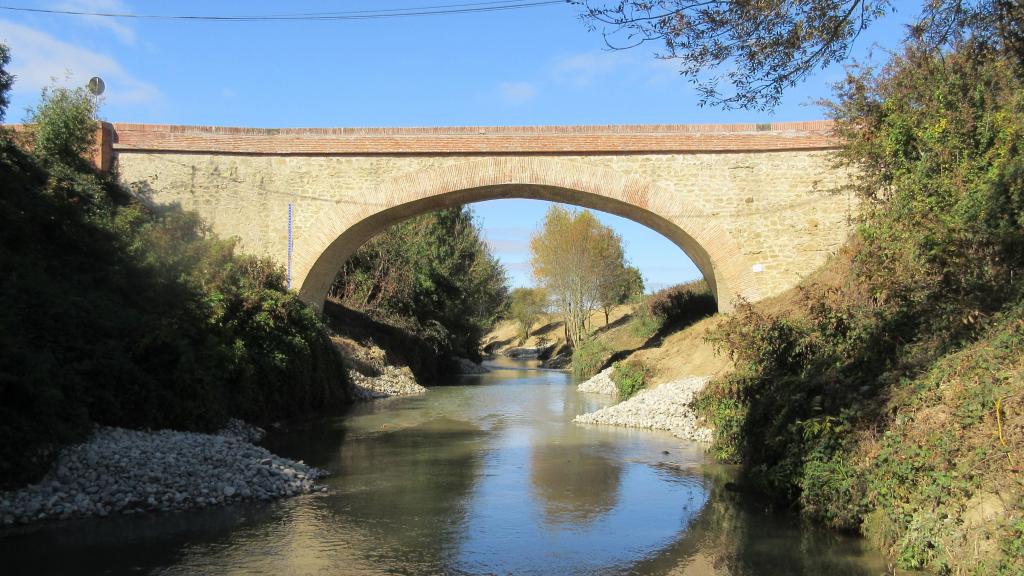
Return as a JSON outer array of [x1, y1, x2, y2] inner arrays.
[[110, 151, 855, 305]]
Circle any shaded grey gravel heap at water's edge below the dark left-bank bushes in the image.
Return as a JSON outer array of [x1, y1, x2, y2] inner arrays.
[[0, 416, 327, 526]]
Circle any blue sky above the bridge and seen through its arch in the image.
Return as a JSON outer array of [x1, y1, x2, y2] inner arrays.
[[0, 0, 913, 288]]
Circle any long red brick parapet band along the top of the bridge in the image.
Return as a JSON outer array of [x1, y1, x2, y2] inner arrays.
[[113, 120, 840, 156]]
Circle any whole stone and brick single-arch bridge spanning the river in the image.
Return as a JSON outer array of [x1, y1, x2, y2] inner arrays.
[[96, 121, 856, 311]]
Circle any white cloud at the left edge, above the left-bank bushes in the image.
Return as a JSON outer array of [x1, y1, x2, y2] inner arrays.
[[0, 19, 161, 105]]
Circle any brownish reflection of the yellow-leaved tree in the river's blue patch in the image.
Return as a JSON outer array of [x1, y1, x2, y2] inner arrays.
[[529, 444, 623, 524]]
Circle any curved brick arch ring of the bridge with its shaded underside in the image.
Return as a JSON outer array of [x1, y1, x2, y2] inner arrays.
[[294, 158, 757, 312]]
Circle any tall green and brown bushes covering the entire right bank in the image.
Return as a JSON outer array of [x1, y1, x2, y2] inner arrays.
[[698, 32, 1024, 574]]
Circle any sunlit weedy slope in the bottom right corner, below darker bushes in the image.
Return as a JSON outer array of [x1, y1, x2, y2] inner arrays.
[[853, 306, 1024, 574]]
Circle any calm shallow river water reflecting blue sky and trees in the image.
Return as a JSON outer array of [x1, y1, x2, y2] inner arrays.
[[0, 361, 886, 576]]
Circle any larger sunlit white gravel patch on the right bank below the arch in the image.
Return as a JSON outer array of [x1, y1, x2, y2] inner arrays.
[[573, 376, 712, 442]]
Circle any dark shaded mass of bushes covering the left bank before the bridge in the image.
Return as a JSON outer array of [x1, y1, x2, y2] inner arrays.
[[0, 75, 348, 488]]
